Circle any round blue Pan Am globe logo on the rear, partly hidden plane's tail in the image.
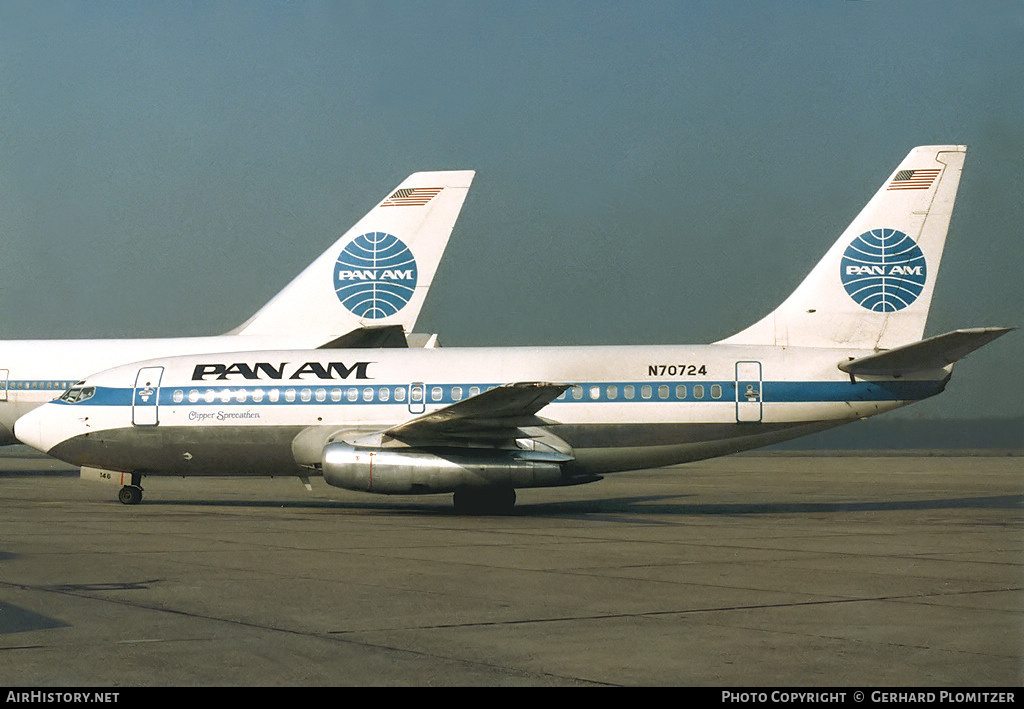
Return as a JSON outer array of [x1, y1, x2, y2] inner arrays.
[[334, 232, 417, 320]]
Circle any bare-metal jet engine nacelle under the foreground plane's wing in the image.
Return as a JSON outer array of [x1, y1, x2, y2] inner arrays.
[[324, 443, 571, 495]]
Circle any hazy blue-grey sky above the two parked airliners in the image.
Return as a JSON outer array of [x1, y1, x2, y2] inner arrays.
[[0, 0, 1024, 418]]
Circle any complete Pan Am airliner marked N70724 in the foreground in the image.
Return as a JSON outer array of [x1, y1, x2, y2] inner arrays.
[[15, 145, 1011, 513]]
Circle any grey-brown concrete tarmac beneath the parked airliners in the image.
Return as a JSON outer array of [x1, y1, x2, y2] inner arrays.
[[0, 453, 1024, 687]]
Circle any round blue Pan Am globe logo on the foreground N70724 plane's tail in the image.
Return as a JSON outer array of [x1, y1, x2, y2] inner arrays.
[[840, 228, 928, 312]]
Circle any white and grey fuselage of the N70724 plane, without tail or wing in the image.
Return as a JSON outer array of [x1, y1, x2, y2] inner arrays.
[[16, 344, 949, 475]]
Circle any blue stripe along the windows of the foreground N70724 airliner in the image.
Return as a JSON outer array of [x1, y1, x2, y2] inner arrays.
[[48, 381, 943, 407]]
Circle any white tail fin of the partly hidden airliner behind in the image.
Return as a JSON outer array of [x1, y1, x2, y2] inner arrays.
[[228, 170, 475, 346]]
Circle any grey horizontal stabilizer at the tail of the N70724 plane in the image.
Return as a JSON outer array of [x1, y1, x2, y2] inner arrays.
[[839, 328, 1014, 376]]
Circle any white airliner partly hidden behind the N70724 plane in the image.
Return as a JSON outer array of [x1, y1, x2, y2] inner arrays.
[[0, 170, 475, 445]]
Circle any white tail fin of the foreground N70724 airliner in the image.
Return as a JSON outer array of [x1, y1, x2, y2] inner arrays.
[[722, 145, 967, 349]]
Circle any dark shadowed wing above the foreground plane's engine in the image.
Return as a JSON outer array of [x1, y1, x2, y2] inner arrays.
[[356, 381, 571, 448]]
